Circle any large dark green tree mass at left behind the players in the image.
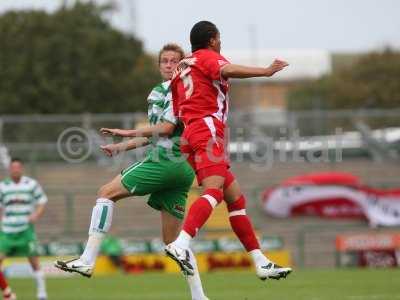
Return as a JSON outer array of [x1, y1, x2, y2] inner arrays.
[[0, 2, 159, 114]]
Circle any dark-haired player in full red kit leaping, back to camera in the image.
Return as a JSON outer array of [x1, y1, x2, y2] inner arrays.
[[165, 21, 292, 280]]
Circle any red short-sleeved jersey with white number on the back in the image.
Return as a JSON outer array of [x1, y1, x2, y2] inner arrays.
[[171, 49, 229, 125]]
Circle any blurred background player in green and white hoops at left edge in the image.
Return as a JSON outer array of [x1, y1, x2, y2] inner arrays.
[[0, 158, 47, 300]]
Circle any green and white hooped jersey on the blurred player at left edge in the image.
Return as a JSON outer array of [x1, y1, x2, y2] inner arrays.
[[0, 176, 47, 233]]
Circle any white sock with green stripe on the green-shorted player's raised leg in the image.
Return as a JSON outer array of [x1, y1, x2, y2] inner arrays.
[[81, 198, 114, 266]]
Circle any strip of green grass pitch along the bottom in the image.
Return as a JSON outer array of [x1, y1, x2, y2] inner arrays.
[[11, 269, 400, 300]]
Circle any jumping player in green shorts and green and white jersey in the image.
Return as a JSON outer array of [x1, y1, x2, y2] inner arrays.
[[55, 44, 207, 300]]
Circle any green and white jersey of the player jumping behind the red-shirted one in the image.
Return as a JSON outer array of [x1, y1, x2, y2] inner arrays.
[[147, 80, 183, 156]]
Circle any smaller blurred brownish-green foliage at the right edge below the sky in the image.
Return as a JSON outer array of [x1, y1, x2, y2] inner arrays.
[[289, 49, 400, 110]]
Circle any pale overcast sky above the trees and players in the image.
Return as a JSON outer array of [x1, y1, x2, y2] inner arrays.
[[0, 0, 400, 52]]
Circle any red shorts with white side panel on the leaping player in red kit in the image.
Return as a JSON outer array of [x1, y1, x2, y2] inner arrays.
[[181, 117, 229, 184]]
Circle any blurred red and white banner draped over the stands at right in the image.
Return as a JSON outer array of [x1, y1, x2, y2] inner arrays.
[[262, 172, 400, 226]]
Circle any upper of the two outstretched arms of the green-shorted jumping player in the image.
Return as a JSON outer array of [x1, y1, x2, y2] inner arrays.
[[100, 122, 176, 138]]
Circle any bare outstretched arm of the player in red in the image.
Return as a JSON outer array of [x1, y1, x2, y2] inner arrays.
[[221, 59, 289, 78]]
